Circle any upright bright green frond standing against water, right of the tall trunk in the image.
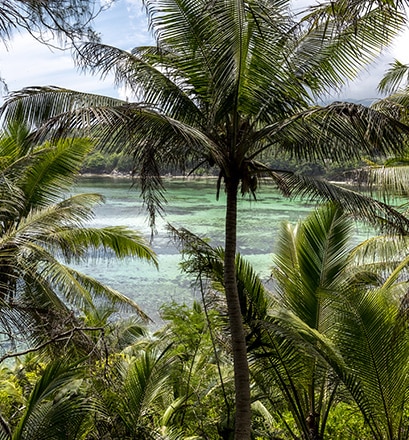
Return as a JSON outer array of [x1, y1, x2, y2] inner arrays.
[[273, 205, 352, 333]]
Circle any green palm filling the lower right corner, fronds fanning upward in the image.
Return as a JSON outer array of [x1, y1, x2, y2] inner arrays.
[[273, 223, 409, 440]]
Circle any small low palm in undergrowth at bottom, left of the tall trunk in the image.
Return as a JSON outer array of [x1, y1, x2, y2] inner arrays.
[[87, 341, 176, 440]]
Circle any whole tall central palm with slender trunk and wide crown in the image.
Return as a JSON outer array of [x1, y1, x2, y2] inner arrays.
[[2, 0, 409, 439]]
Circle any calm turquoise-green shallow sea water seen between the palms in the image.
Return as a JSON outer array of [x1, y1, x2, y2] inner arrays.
[[74, 177, 368, 322]]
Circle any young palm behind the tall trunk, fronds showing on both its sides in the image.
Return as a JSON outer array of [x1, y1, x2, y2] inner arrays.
[[169, 206, 352, 440]]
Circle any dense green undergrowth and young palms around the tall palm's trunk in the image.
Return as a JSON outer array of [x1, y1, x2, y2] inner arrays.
[[0, 205, 409, 440]]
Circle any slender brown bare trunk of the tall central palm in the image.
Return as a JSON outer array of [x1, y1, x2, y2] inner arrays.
[[224, 178, 251, 440]]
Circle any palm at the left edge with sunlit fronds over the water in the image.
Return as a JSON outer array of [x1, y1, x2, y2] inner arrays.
[[0, 123, 156, 356]]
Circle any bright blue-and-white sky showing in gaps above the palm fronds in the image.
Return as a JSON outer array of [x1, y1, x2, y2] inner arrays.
[[0, 0, 409, 105]]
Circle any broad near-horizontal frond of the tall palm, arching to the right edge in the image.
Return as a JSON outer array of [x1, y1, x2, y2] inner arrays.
[[255, 102, 409, 163]]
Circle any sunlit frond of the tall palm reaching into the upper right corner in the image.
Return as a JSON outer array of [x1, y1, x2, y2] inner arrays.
[[297, 0, 406, 93]]
